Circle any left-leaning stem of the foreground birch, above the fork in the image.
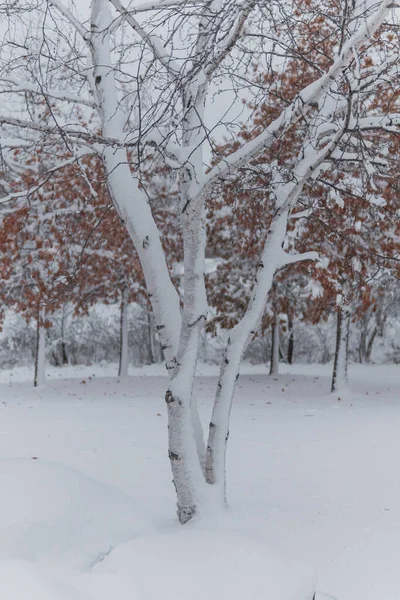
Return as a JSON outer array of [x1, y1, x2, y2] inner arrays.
[[91, 0, 181, 369]]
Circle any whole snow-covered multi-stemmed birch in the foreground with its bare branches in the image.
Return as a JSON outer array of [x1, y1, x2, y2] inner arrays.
[[0, 0, 399, 523]]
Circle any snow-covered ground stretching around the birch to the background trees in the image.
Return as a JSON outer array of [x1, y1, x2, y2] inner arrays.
[[0, 365, 400, 600]]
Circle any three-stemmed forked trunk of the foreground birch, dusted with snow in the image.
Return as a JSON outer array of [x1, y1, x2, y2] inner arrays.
[[90, 0, 382, 522]]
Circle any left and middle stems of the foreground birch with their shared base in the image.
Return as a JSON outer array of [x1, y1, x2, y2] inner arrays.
[[91, 0, 206, 523]]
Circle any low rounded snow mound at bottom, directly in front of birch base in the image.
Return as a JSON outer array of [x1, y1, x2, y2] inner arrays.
[[95, 526, 315, 600]]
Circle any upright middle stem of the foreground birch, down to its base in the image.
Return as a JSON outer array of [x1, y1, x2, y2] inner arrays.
[[166, 78, 207, 523]]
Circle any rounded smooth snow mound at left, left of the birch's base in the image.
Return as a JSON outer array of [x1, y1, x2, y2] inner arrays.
[[0, 458, 151, 568]]
